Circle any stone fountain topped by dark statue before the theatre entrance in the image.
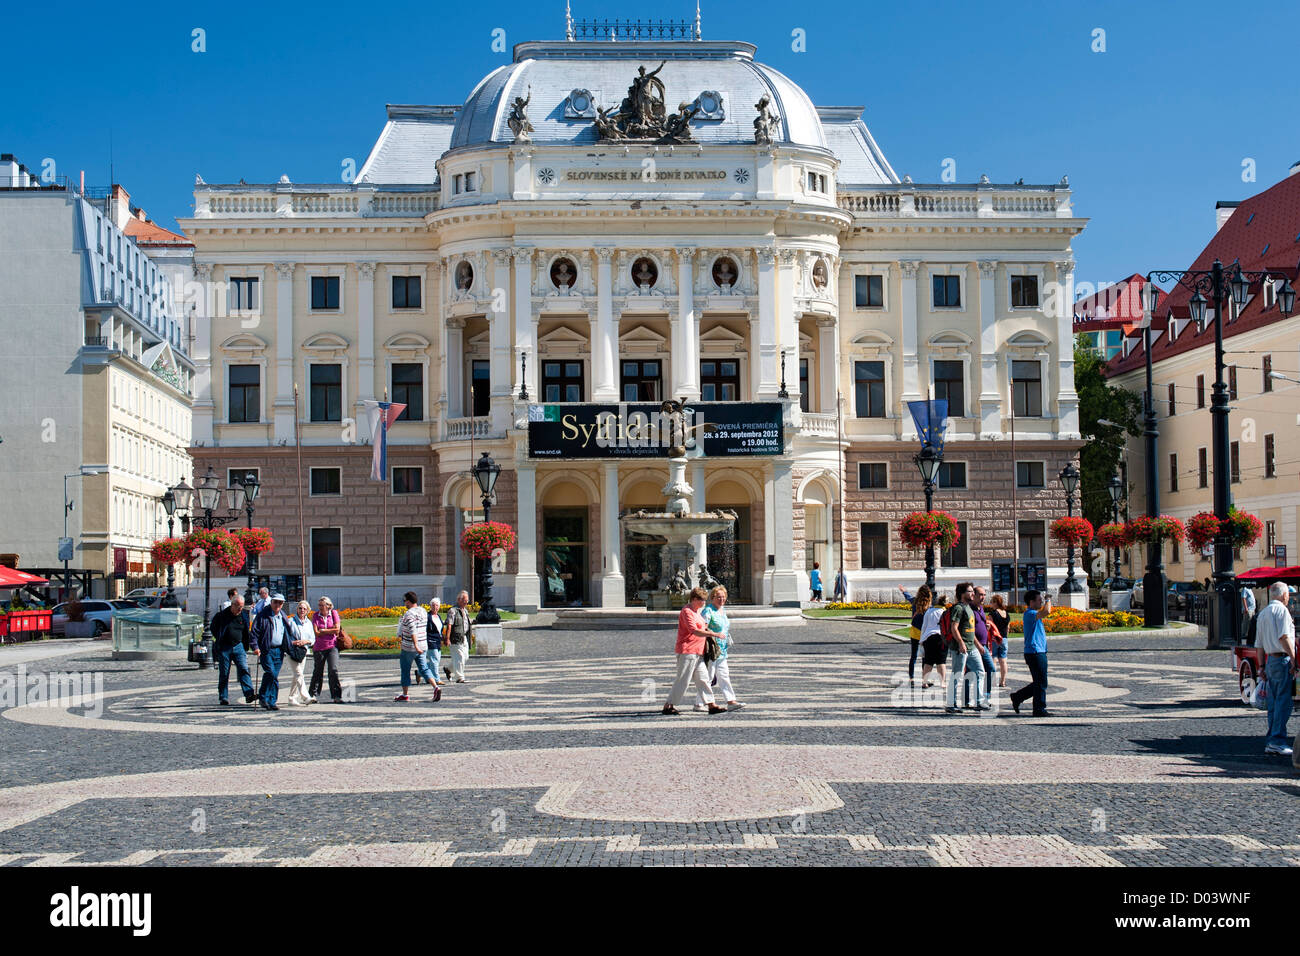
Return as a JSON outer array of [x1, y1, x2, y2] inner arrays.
[[623, 401, 736, 609]]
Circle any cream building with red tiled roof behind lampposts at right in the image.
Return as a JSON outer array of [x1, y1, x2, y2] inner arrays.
[[1108, 164, 1300, 581]]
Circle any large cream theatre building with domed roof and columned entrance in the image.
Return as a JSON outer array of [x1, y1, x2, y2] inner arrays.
[[182, 30, 1084, 609]]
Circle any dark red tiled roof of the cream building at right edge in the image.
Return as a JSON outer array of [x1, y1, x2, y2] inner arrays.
[[1106, 174, 1300, 375]]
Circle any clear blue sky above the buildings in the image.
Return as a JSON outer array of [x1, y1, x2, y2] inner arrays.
[[0, 0, 1300, 291]]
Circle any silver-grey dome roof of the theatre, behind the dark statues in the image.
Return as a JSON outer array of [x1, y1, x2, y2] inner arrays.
[[451, 40, 828, 150]]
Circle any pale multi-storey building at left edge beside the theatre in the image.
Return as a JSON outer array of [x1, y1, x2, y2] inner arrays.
[[0, 155, 194, 596]]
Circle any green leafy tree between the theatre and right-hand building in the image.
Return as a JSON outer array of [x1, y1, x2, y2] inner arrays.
[[1074, 336, 1141, 527]]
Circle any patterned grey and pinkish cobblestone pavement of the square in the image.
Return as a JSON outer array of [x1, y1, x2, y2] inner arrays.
[[0, 618, 1300, 866]]
